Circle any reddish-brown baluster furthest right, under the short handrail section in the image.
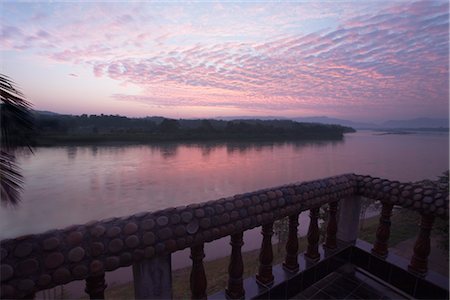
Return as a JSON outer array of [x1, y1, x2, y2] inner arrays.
[[408, 214, 434, 275]]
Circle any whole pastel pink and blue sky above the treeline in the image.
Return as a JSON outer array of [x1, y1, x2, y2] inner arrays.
[[0, 0, 449, 122]]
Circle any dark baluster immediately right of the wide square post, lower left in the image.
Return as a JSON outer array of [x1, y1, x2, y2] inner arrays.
[[190, 243, 207, 299]]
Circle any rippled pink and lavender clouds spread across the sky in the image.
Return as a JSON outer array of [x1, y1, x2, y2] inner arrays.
[[0, 1, 449, 119]]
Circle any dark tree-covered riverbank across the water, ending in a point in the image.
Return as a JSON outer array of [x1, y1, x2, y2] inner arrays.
[[36, 113, 354, 145]]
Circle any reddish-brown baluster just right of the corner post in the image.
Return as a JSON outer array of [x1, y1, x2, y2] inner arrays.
[[371, 203, 394, 258]]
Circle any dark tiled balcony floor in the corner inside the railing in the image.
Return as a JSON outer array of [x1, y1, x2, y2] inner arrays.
[[293, 264, 410, 299]]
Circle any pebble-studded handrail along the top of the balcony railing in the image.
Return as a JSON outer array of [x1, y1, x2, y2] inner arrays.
[[1, 174, 448, 297]]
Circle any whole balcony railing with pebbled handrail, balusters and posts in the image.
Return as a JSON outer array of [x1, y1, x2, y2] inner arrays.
[[1, 174, 449, 299]]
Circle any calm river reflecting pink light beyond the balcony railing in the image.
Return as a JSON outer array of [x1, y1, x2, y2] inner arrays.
[[0, 131, 449, 296]]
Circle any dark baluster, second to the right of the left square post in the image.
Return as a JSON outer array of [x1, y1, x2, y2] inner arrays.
[[225, 232, 245, 299]]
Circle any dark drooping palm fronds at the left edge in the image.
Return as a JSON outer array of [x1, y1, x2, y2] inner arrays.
[[0, 74, 34, 204]]
